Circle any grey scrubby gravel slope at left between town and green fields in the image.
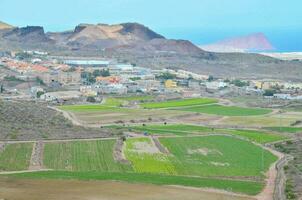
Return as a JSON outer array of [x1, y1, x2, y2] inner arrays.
[[0, 100, 113, 140]]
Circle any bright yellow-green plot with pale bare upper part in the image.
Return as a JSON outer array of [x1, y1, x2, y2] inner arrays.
[[125, 138, 175, 174]]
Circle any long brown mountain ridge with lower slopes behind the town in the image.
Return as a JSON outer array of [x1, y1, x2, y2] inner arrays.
[[0, 23, 302, 81]]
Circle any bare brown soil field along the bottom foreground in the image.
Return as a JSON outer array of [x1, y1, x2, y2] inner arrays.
[[0, 178, 254, 200]]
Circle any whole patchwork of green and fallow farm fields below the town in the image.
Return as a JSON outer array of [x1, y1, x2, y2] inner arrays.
[[0, 96, 292, 195]]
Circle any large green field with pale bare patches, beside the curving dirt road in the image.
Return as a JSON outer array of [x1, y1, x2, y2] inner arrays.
[[160, 136, 277, 177]]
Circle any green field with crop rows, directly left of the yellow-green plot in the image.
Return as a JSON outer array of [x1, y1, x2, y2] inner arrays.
[[43, 140, 132, 172]]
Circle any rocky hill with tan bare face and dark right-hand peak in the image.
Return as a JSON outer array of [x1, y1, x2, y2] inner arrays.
[[47, 23, 164, 49]]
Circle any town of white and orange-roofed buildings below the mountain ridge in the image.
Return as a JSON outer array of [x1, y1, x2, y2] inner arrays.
[[0, 51, 302, 104]]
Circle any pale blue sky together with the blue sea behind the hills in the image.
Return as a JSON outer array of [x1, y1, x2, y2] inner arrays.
[[0, 0, 302, 51]]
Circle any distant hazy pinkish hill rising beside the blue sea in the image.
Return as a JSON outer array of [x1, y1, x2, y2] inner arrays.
[[201, 33, 274, 52]]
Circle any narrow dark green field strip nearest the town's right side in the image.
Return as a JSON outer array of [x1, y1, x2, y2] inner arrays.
[[180, 105, 272, 116]]
